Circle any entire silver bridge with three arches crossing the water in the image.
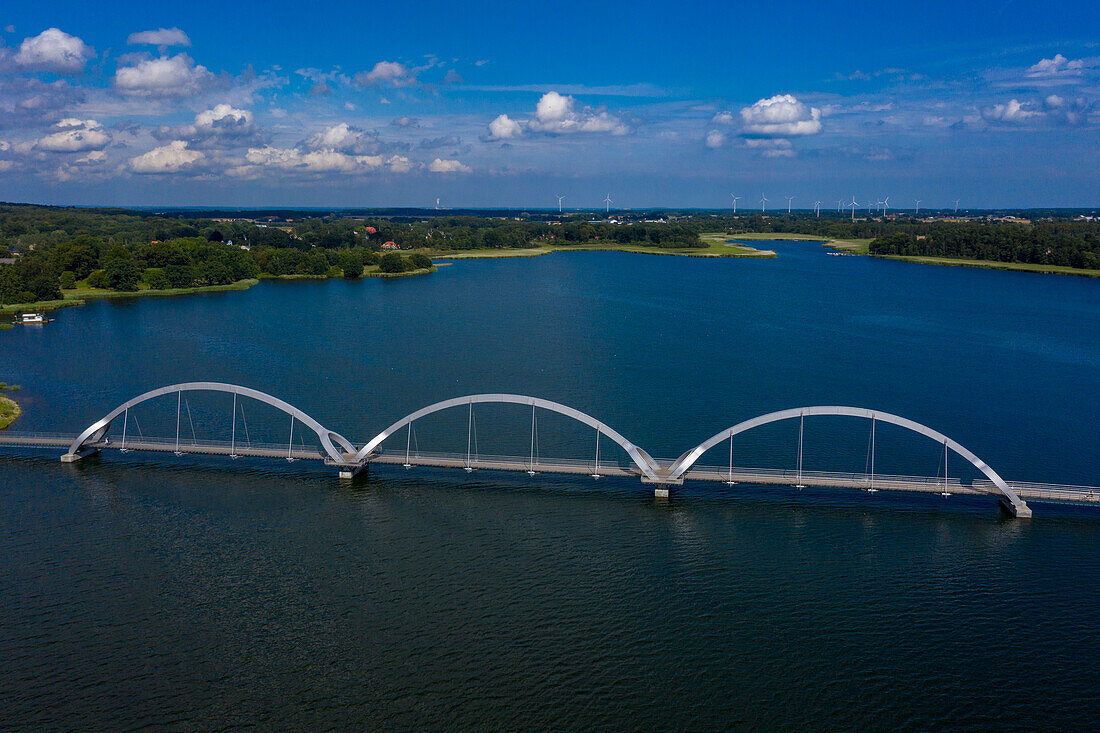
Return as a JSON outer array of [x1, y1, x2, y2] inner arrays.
[[0, 382, 1100, 517]]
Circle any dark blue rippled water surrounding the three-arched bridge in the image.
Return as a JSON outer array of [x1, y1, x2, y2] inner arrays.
[[0, 243, 1100, 730]]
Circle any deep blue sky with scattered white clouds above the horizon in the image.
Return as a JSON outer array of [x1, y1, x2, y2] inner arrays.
[[0, 0, 1100, 208]]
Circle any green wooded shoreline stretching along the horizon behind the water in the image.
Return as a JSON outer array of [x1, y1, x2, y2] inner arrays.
[[0, 204, 1100, 305]]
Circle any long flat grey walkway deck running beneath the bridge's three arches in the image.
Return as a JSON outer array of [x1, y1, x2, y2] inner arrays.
[[0, 431, 1100, 505]]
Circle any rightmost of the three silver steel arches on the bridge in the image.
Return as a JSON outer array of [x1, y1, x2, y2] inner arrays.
[[667, 405, 1030, 514]]
